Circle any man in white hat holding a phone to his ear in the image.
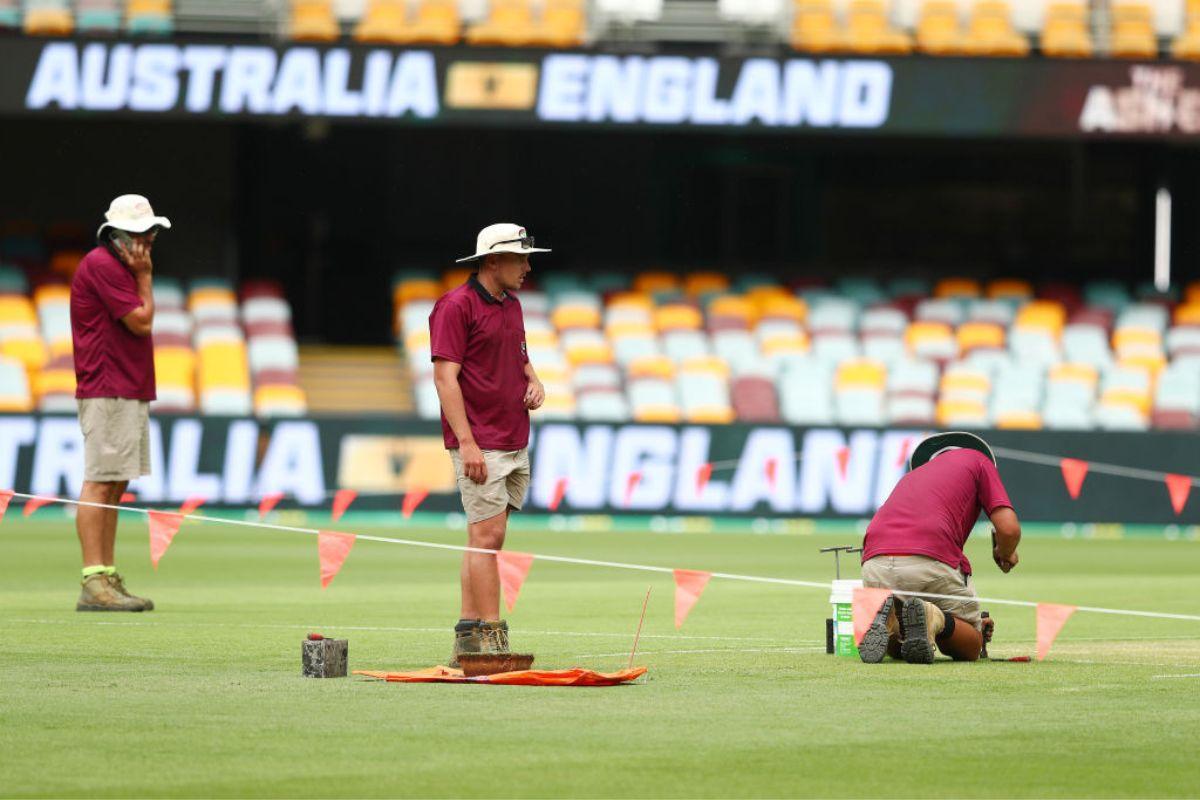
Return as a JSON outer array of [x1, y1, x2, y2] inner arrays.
[[71, 194, 170, 612]]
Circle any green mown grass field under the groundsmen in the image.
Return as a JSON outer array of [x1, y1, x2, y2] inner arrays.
[[0, 513, 1200, 798]]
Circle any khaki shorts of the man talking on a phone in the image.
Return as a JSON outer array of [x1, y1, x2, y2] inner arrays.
[[76, 397, 150, 483]]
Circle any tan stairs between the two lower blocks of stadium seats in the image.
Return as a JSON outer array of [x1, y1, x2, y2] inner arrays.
[[300, 345, 414, 414]]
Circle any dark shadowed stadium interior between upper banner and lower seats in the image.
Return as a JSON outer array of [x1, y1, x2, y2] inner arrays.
[[0, 121, 1200, 342]]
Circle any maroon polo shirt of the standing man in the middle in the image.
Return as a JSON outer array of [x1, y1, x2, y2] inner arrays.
[[430, 275, 529, 450]]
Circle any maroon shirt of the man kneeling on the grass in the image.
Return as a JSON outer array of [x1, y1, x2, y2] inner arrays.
[[863, 449, 1013, 575]]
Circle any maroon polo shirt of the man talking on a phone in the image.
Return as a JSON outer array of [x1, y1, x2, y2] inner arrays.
[[71, 246, 156, 401]]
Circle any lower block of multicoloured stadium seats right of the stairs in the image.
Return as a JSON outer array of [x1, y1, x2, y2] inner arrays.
[[394, 270, 1200, 429]]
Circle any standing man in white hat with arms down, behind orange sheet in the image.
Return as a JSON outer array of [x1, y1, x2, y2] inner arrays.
[[430, 223, 550, 667]]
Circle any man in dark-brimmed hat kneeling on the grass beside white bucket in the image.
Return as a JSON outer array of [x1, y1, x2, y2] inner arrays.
[[858, 431, 1021, 663]]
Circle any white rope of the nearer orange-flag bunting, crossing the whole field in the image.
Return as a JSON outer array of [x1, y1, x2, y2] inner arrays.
[[12, 492, 1200, 622]]
